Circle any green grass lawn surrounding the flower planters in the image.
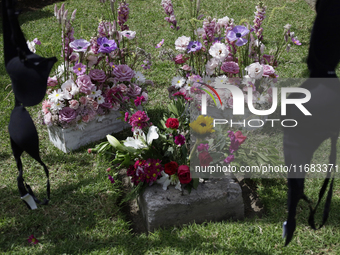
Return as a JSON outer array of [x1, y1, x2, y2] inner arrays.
[[0, 0, 340, 255]]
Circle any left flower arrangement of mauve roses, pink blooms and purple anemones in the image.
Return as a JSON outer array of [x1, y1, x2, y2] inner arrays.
[[39, 1, 152, 129]]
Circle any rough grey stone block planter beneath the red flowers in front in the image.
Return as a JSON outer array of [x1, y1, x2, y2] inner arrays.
[[137, 177, 244, 232]]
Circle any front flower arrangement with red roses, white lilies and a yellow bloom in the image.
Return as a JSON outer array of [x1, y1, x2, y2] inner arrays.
[[90, 89, 278, 197]]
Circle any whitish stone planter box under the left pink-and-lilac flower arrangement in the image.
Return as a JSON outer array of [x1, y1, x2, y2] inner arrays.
[[47, 111, 131, 153]]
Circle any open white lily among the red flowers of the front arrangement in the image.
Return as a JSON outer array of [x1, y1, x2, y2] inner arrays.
[[124, 126, 159, 149]]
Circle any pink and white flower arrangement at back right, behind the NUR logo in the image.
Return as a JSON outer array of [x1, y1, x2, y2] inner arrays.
[[159, 0, 301, 109]]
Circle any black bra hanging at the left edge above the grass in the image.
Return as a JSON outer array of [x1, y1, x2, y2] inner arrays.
[[2, 0, 57, 209]]
